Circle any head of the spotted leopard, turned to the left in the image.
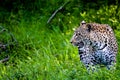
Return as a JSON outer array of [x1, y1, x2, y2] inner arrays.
[[70, 21, 92, 47]]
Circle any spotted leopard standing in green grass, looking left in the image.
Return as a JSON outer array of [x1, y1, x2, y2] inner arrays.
[[70, 21, 118, 70]]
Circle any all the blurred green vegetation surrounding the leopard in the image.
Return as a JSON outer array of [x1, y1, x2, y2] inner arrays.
[[0, 0, 120, 80]]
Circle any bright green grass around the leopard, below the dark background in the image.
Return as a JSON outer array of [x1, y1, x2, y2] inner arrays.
[[0, 6, 120, 80]]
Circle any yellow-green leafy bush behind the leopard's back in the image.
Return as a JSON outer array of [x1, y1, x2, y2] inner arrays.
[[80, 5, 120, 29]]
